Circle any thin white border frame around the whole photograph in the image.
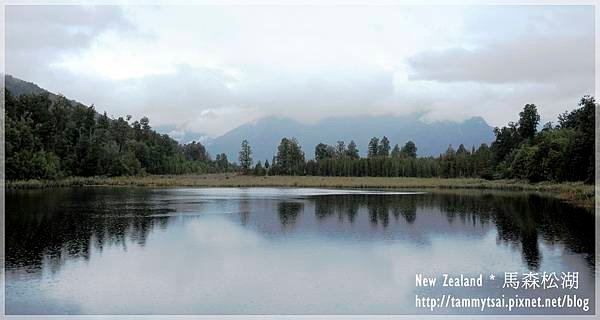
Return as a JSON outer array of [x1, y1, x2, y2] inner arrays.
[[0, 0, 600, 320]]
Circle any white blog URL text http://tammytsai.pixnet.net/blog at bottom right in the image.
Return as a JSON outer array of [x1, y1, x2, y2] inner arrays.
[[415, 294, 590, 312]]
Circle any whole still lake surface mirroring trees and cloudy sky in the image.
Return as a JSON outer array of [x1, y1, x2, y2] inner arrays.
[[6, 187, 595, 314]]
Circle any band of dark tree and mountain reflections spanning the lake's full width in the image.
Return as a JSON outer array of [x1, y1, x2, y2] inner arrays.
[[6, 188, 595, 271]]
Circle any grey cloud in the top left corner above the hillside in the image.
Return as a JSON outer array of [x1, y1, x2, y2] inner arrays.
[[5, 5, 134, 78]]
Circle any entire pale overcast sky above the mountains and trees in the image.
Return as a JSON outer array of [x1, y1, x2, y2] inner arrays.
[[5, 6, 594, 137]]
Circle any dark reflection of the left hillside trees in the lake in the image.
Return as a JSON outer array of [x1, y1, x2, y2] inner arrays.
[[6, 190, 176, 270]]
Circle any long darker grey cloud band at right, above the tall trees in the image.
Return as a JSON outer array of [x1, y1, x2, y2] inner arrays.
[[408, 34, 594, 84]]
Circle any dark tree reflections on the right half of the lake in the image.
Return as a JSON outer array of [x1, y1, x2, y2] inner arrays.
[[313, 191, 594, 270]]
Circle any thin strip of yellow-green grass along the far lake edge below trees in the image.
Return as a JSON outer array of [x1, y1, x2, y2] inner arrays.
[[6, 174, 595, 208]]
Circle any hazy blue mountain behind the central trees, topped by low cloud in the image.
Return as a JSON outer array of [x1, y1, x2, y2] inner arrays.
[[207, 114, 494, 162]]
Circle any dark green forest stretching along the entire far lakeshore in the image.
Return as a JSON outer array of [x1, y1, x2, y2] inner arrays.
[[5, 90, 596, 183]]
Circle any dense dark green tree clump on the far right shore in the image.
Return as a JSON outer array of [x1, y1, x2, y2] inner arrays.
[[492, 96, 596, 183]]
